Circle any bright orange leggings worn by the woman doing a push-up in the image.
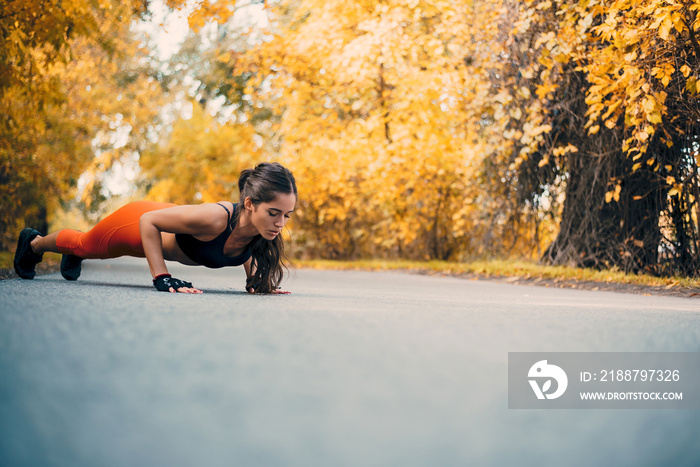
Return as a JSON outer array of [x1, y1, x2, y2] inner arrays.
[[56, 201, 175, 259]]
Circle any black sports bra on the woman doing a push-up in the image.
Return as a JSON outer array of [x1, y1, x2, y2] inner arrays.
[[175, 203, 252, 268]]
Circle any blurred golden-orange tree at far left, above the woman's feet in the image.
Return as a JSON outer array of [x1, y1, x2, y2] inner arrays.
[[0, 0, 186, 248]]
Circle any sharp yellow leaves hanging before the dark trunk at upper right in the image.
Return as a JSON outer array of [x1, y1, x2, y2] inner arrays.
[[514, 0, 700, 212]]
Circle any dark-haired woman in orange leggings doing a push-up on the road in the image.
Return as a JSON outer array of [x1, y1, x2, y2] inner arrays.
[[14, 163, 297, 293]]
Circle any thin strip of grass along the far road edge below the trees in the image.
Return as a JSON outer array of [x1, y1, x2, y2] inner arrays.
[[294, 260, 700, 288]]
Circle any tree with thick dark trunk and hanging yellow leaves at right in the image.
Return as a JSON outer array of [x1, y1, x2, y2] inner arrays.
[[514, 0, 700, 274]]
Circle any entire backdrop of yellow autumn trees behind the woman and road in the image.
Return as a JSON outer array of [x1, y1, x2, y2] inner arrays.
[[0, 0, 700, 275]]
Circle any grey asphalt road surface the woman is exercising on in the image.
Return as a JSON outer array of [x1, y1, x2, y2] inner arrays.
[[0, 259, 700, 467]]
